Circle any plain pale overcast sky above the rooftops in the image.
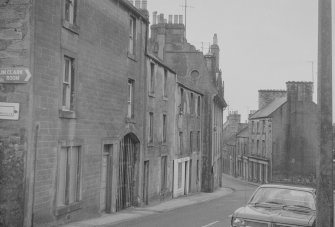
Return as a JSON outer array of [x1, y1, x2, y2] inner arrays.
[[148, 0, 335, 121]]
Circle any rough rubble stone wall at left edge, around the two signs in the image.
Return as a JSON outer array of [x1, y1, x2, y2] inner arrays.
[[0, 0, 32, 227]]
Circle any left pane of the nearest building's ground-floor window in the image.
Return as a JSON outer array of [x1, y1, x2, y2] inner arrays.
[[57, 148, 67, 206]]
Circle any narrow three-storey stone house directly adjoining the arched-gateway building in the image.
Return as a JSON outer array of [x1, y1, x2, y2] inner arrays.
[[143, 53, 177, 204]]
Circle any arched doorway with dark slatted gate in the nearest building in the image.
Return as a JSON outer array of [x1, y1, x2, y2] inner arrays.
[[116, 133, 140, 211]]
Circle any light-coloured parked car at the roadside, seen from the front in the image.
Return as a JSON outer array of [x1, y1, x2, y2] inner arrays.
[[231, 184, 316, 227]]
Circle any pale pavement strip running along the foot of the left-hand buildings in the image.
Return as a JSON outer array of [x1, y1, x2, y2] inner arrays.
[[62, 178, 236, 227]]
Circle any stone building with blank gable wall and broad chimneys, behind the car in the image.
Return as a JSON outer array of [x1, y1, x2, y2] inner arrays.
[[249, 82, 318, 184]]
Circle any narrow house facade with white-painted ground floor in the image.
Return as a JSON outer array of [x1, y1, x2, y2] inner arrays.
[[173, 82, 204, 197]]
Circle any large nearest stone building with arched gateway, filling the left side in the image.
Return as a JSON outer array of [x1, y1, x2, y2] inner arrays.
[[0, 0, 149, 226]]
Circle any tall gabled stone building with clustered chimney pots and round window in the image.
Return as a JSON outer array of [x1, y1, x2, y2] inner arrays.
[[150, 12, 226, 191]]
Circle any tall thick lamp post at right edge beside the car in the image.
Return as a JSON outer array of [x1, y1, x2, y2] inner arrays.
[[316, 0, 334, 227]]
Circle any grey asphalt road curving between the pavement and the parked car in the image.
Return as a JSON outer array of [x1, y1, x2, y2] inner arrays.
[[111, 177, 256, 227]]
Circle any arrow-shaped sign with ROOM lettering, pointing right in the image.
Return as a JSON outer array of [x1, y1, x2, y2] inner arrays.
[[0, 68, 31, 84]]
